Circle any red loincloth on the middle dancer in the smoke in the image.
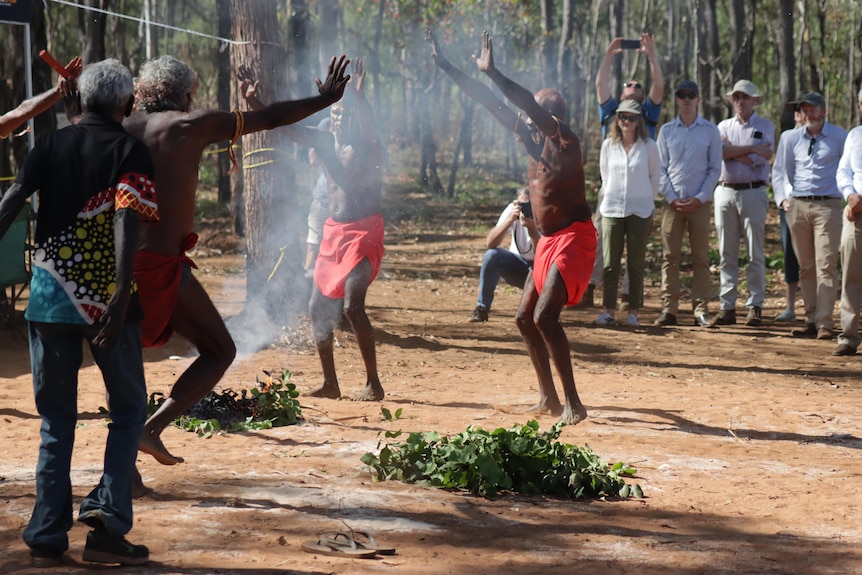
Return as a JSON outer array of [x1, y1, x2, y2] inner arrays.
[[314, 214, 384, 299]]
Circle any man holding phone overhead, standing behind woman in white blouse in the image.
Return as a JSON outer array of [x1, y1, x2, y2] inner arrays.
[[588, 33, 664, 308]]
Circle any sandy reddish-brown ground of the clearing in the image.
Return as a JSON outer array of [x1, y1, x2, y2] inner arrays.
[[0, 196, 862, 575]]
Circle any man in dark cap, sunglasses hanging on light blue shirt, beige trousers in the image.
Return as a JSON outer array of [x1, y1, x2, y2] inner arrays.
[[772, 92, 847, 339]]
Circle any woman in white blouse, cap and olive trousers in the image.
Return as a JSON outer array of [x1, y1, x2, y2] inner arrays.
[[596, 100, 659, 326]]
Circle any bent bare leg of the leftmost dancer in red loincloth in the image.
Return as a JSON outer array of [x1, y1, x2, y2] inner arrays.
[[140, 276, 236, 465]]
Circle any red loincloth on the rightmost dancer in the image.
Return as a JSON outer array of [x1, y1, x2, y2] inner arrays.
[[533, 220, 596, 305]]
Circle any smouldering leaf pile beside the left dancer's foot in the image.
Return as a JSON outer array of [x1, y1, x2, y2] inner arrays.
[[148, 371, 302, 437]]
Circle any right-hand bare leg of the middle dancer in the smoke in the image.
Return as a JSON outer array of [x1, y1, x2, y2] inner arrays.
[[344, 259, 384, 401]]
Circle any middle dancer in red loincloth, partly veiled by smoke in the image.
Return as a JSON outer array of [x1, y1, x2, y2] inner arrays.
[[240, 60, 386, 401]]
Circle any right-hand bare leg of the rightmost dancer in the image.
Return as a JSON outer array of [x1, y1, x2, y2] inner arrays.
[[533, 264, 587, 425]]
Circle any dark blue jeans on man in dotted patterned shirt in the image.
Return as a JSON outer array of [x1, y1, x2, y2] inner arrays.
[[24, 322, 147, 551]]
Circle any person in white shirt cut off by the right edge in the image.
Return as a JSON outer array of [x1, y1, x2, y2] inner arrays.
[[832, 86, 862, 356]]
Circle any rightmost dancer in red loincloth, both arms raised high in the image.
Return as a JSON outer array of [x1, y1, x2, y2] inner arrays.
[[425, 30, 596, 424]]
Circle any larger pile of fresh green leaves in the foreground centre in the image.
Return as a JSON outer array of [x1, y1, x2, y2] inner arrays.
[[362, 421, 643, 499]]
